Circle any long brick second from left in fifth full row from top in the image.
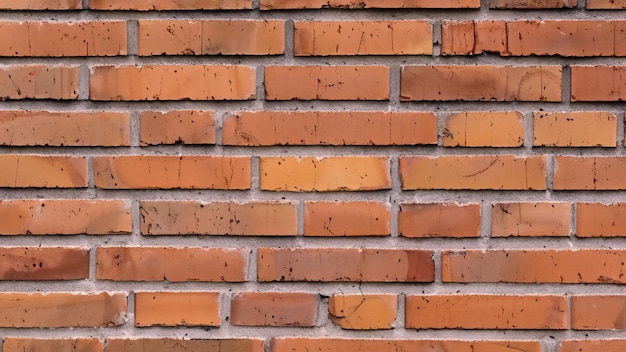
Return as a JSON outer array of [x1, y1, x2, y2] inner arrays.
[[140, 201, 298, 236]]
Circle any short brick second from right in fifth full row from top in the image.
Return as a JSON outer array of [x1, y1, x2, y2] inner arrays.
[[491, 203, 571, 237]]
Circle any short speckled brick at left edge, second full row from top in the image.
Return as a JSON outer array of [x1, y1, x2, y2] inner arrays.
[[0, 65, 78, 100]]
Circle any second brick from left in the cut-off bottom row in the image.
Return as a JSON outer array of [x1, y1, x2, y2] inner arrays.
[[104, 338, 265, 352]]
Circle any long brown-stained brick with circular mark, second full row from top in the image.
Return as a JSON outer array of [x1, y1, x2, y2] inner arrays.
[[400, 65, 562, 102]]
